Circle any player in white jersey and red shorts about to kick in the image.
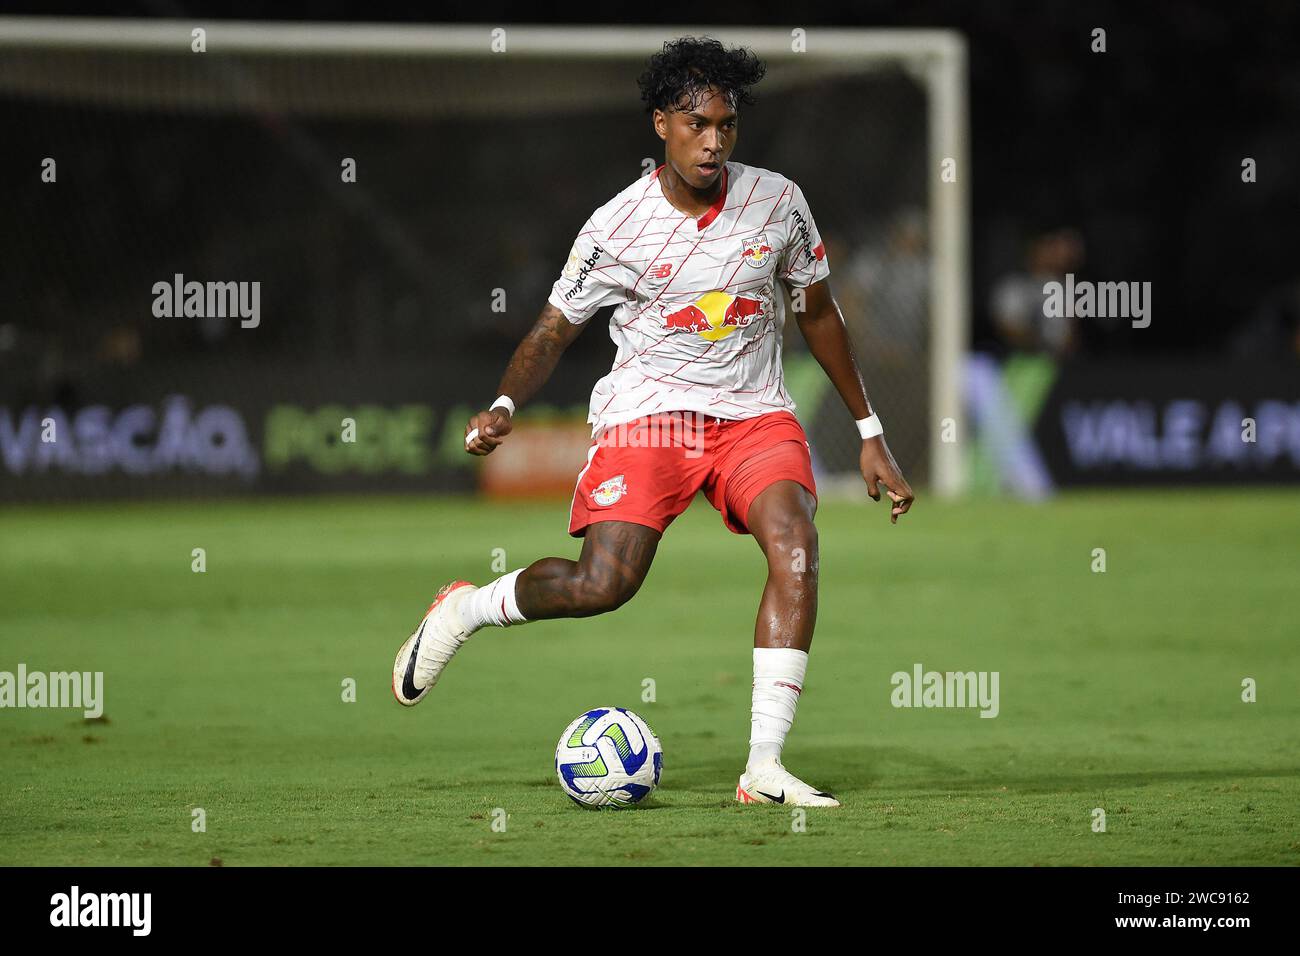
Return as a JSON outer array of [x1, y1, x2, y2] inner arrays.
[[393, 38, 914, 806]]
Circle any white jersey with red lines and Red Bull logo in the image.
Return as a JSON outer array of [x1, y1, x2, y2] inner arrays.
[[549, 163, 831, 437]]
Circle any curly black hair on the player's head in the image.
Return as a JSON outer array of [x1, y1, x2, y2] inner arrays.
[[637, 36, 767, 113]]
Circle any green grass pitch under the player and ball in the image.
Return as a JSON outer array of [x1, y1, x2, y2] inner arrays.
[[0, 490, 1300, 865]]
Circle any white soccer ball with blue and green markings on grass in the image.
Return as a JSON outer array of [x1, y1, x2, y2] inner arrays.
[[555, 708, 663, 809]]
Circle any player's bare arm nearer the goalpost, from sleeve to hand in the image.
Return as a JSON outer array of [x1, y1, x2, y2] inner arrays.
[[797, 278, 917, 524]]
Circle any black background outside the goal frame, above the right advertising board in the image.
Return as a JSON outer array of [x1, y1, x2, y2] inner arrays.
[[4, 0, 1300, 360]]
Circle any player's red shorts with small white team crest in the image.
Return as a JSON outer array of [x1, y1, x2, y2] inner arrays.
[[569, 410, 816, 537]]
